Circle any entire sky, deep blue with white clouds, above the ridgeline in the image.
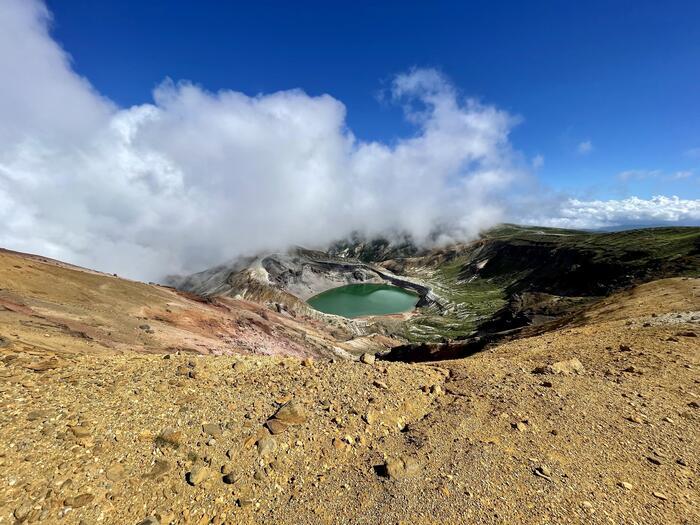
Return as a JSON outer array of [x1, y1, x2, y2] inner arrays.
[[0, 0, 700, 280]]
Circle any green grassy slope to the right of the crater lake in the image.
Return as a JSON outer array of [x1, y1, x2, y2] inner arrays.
[[396, 224, 700, 342]]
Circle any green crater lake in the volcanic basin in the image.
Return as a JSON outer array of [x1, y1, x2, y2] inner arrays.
[[307, 284, 419, 318]]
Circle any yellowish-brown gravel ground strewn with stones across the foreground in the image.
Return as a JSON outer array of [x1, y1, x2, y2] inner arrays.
[[0, 272, 700, 524]]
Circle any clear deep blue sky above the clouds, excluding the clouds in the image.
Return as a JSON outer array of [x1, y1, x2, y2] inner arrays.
[[48, 0, 700, 199]]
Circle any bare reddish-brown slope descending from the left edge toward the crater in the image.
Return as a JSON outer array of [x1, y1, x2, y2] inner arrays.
[[0, 250, 396, 357]]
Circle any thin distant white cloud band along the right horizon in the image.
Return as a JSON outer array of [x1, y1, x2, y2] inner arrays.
[[522, 195, 700, 229]]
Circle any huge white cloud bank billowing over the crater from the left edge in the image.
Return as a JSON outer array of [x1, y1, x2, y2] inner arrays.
[[0, 0, 697, 279]]
